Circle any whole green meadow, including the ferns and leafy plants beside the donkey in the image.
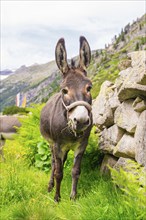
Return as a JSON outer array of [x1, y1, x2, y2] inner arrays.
[[0, 106, 146, 220]]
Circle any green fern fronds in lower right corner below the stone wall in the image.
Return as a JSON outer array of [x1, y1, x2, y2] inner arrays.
[[111, 161, 146, 219]]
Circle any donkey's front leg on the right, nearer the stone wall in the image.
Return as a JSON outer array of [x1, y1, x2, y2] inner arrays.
[[70, 149, 85, 199]]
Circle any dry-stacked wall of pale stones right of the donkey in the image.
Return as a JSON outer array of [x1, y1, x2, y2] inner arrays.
[[93, 51, 146, 172]]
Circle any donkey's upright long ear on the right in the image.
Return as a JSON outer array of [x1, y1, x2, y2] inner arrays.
[[79, 36, 91, 70]]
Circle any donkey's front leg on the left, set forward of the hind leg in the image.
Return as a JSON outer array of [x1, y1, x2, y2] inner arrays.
[[54, 144, 63, 202]]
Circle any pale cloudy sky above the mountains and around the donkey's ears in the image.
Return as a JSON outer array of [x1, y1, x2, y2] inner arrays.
[[1, 0, 145, 70]]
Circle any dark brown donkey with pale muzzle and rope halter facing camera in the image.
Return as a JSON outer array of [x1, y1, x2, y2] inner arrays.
[[40, 36, 92, 202]]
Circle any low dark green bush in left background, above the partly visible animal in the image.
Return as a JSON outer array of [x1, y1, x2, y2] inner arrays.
[[3, 106, 29, 115]]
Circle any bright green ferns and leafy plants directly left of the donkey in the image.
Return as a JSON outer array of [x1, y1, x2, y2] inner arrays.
[[17, 105, 50, 171]]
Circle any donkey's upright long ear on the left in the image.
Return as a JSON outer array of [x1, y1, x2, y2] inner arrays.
[[55, 38, 69, 74]]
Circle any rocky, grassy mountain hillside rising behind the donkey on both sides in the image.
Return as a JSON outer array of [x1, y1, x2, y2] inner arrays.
[[0, 15, 146, 111]]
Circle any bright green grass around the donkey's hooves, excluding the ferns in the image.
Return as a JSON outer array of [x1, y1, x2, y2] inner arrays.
[[0, 139, 145, 220]]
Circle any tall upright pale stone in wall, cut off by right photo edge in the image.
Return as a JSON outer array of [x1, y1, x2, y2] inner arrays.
[[135, 110, 146, 167]]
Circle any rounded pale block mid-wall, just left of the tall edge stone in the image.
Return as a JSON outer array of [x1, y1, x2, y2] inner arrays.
[[114, 100, 139, 133]]
